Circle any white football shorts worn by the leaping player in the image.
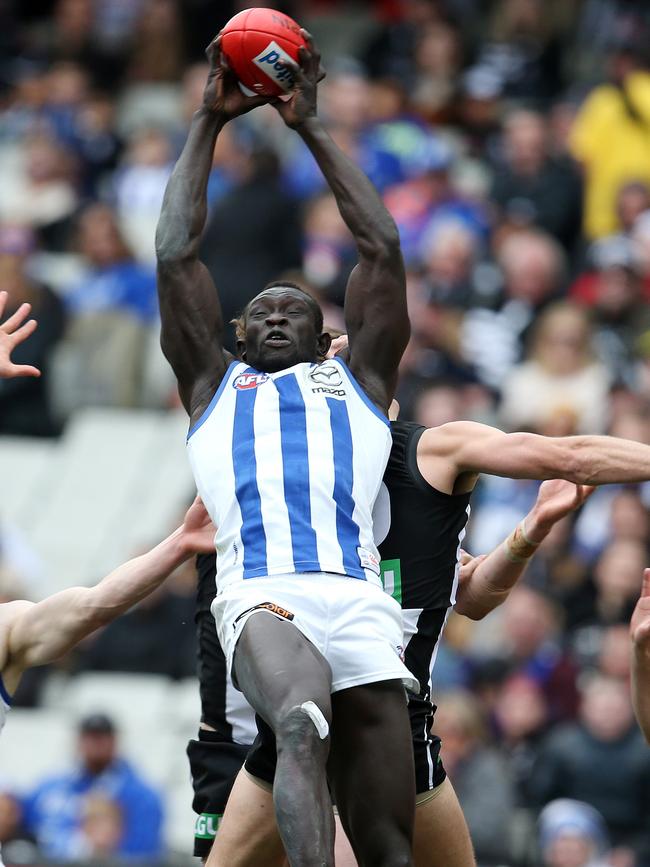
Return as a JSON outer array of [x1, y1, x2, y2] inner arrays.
[[212, 572, 419, 692]]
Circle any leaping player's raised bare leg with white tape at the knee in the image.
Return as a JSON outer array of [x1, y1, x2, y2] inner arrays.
[[234, 612, 334, 867]]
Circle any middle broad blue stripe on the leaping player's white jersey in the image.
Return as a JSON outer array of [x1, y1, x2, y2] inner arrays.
[[275, 373, 320, 572]]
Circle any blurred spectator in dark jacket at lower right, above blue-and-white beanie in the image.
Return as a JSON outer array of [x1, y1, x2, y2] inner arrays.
[[530, 675, 650, 863]]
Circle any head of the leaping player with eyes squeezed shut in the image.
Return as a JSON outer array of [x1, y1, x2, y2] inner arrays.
[[238, 287, 321, 373]]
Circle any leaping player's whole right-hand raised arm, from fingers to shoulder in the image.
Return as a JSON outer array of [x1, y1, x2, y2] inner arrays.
[[275, 30, 410, 411]]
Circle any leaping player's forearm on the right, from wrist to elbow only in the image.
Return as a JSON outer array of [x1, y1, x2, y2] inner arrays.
[[297, 117, 399, 255]]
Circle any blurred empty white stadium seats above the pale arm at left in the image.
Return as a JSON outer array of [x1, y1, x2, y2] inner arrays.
[[0, 409, 194, 593]]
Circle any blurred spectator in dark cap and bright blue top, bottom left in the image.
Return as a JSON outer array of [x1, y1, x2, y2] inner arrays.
[[25, 714, 163, 861]]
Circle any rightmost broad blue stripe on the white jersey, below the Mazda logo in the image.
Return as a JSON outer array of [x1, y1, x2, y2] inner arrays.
[[326, 397, 366, 580]]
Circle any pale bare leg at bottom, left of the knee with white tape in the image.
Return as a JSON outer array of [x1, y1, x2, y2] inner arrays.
[[206, 770, 287, 867]]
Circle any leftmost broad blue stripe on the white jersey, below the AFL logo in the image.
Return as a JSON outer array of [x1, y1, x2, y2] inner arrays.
[[232, 376, 267, 578]]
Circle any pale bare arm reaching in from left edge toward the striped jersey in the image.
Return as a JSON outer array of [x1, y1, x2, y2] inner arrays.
[[2, 498, 214, 692]]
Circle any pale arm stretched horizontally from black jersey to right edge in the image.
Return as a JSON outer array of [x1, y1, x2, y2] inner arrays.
[[418, 421, 650, 487]]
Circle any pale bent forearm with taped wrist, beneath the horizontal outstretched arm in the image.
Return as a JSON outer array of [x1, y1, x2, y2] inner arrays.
[[455, 479, 592, 620]]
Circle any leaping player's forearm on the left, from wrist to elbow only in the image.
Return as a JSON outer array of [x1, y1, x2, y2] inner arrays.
[[156, 108, 225, 264]]
